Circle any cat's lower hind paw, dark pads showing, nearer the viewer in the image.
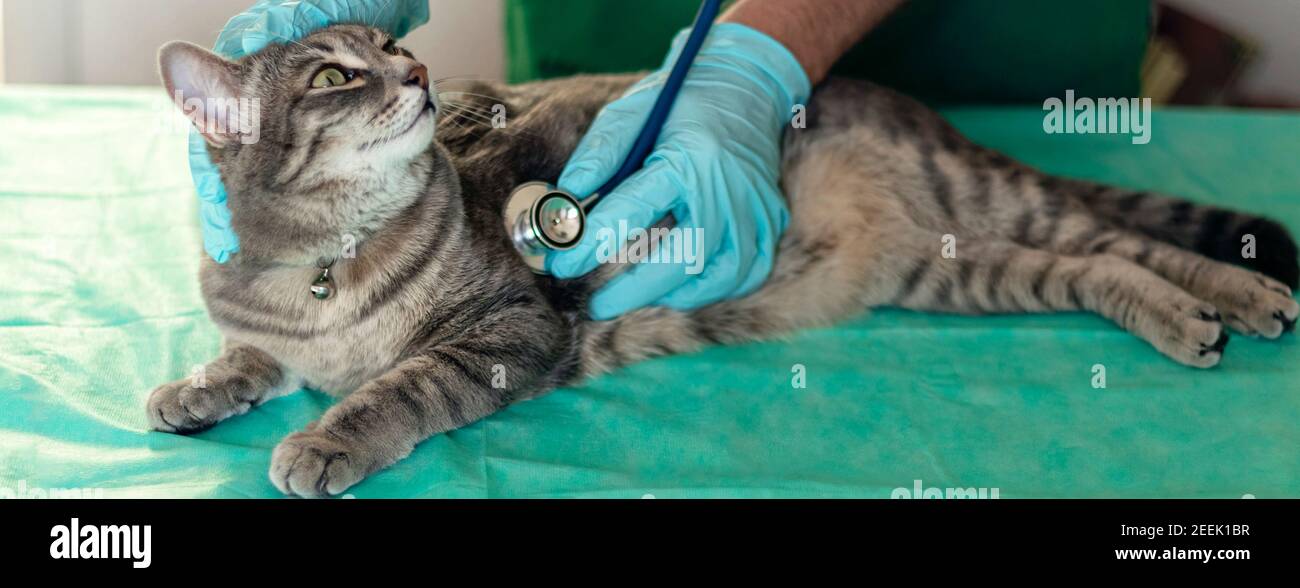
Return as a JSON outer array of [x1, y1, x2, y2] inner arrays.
[[1152, 297, 1229, 368]]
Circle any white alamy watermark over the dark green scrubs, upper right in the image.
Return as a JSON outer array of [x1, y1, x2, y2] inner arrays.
[[1043, 90, 1151, 144]]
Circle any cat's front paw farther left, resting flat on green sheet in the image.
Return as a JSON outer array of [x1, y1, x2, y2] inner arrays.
[[147, 380, 251, 434]]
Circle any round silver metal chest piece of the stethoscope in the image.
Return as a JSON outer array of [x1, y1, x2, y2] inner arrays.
[[506, 182, 586, 273]]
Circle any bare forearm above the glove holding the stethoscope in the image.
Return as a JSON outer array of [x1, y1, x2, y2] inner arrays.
[[722, 0, 905, 85]]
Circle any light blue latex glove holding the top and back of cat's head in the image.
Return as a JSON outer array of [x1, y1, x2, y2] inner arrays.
[[190, 0, 429, 263]]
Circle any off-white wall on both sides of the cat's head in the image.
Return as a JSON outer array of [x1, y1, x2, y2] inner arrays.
[[0, 0, 504, 85]]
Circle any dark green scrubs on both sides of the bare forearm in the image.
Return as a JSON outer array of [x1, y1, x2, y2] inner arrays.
[[506, 0, 1151, 104]]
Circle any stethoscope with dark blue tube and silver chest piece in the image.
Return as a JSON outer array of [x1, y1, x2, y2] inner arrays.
[[506, 0, 722, 274]]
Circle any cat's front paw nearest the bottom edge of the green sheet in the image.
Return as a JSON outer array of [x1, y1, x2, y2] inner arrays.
[[270, 431, 365, 498]]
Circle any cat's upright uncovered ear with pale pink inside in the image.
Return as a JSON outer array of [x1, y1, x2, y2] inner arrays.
[[159, 40, 250, 147]]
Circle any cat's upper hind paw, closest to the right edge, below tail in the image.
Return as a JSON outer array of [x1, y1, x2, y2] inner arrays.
[[1214, 273, 1300, 340]]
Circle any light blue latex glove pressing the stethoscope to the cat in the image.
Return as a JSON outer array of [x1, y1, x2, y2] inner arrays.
[[547, 23, 811, 320]]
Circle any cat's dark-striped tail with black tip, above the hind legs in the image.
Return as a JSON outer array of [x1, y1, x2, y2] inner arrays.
[[1080, 180, 1300, 290]]
